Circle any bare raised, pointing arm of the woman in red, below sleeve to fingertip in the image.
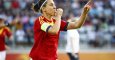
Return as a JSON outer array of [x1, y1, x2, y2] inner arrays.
[[67, 0, 92, 29]]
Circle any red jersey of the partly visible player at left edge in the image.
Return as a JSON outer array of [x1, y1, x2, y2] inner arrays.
[[0, 27, 11, 51]]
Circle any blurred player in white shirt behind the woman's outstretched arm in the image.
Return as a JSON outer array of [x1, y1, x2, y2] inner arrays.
[[66, 13, 79, 60]]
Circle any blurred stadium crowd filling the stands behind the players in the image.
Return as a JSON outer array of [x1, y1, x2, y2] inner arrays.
[[0, 0, 115, 47]]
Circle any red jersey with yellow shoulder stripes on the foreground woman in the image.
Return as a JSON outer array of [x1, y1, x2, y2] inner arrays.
[[30, 16, 68, 60]]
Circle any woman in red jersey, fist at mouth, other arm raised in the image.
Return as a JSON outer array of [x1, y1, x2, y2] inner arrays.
[[30, 0, 91, 60]]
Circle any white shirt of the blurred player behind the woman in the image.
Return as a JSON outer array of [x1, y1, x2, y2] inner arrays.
[[66, 30, 79, 53]]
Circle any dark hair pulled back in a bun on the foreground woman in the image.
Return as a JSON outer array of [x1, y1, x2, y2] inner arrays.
[[32, 0, 47, 13]]
